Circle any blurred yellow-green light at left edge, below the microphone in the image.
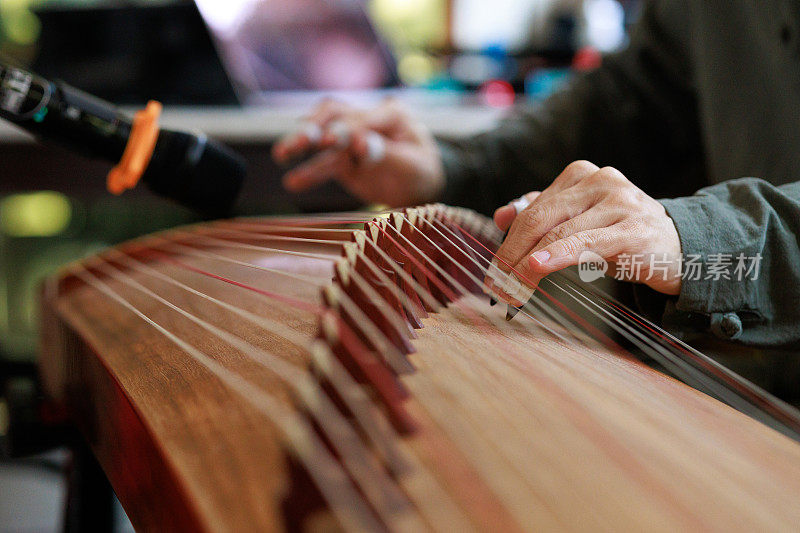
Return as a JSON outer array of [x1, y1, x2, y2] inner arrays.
[[0, 191, 72, 237]]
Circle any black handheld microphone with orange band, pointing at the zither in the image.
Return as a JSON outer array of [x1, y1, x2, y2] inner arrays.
[[0, 63, 246, 216]]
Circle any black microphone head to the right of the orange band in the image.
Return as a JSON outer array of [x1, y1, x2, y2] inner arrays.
[[142, 130, 246, 217]]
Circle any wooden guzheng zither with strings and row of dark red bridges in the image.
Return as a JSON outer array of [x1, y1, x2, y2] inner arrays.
[[41, 205, 800, 531]]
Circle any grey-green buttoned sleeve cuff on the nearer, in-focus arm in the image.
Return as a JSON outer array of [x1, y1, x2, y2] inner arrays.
[[661, 178, 800, 346]]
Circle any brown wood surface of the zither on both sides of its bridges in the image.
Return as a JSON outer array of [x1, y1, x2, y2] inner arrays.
[[40, 217, 800, 531]]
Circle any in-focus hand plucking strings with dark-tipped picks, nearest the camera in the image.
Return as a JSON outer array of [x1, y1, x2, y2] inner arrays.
[[486, 161, 681, 305]]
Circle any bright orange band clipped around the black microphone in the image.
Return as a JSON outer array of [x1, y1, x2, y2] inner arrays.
[[106, 100, 162, 194]]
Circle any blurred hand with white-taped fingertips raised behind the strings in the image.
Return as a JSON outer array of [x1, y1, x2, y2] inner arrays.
[[273, 99, 444, 207]]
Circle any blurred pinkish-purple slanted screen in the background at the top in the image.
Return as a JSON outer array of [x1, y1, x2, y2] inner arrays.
[[195, 0, 399, 100]]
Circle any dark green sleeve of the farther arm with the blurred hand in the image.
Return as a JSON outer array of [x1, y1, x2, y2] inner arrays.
[[440, 0, 707, 213]]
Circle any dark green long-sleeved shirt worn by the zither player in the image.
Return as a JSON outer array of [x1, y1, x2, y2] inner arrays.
[[442, 0, 800, 347]]
